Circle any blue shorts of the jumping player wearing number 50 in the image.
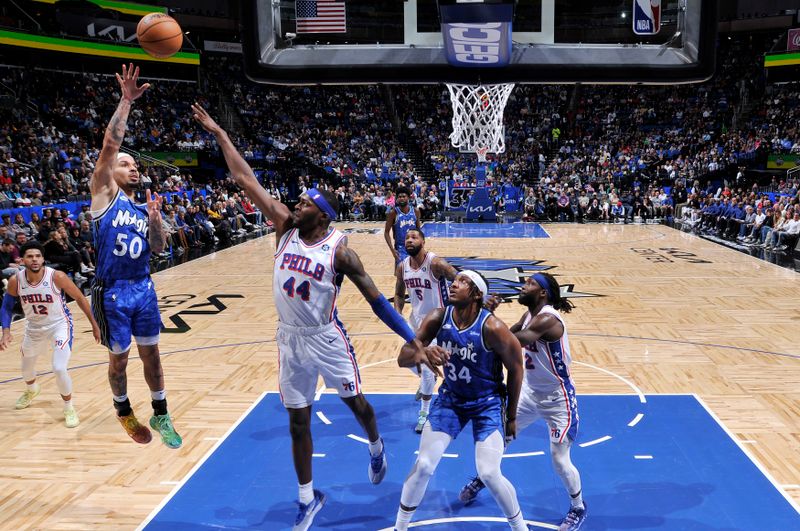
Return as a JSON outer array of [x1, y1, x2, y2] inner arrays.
[[92, 277, 162, 354]]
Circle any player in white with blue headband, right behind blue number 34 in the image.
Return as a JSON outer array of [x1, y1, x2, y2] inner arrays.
[[459, 273, 586, 531]]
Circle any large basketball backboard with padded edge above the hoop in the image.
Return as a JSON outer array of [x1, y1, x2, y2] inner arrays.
[[242, 0, 717, 85]]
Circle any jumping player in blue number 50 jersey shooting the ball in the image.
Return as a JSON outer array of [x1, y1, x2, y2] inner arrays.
[[89, 64, 182, 448]]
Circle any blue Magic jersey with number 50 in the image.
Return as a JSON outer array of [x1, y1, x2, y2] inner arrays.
[[92, 190, 150, 282]]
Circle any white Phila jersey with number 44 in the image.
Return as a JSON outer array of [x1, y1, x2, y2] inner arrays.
[[272, 229, 344, 327]]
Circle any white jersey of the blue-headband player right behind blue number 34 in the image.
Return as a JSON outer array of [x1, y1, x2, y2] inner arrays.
[[522, 304, 572, 391]]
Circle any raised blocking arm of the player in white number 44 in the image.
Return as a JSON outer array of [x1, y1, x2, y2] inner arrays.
[[192, 103, 291, 239]]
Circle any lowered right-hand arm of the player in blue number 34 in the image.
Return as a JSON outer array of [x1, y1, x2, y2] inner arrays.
[[483, 316, 525, 442]]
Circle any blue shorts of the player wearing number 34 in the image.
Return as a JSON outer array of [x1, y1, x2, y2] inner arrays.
[[428, 389, 505, 442]]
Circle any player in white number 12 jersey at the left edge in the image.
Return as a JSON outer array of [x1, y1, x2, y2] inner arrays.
[[0, 242, 100, 428]]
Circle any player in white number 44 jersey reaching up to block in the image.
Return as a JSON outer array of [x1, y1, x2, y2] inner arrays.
[[192, 104, 424, 531]]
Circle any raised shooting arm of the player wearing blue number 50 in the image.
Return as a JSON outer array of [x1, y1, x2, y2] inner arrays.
[[89, 63, 150, 210]]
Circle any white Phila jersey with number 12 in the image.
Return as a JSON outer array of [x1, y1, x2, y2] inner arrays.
[[17, 267, 72, 334]]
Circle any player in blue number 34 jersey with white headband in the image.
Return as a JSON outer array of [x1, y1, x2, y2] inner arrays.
[[394, 270, 527, 531]]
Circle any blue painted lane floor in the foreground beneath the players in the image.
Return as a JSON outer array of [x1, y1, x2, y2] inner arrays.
[[144, 393, 800, 531]]
